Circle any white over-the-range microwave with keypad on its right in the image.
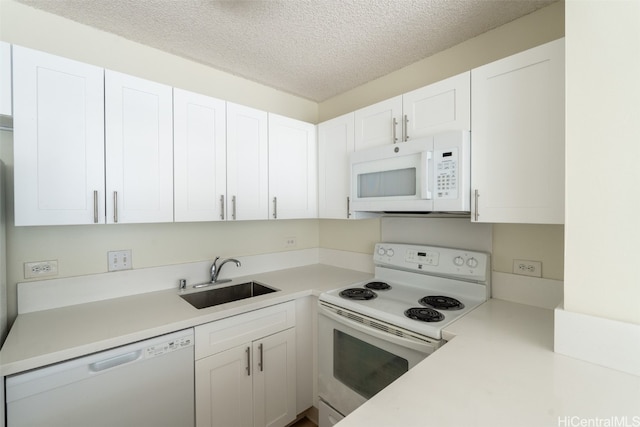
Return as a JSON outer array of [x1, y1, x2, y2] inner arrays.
[[349, 130, 471, 214]]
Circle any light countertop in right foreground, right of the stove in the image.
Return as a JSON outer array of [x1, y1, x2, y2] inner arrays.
[[338, 299, 640, 427]]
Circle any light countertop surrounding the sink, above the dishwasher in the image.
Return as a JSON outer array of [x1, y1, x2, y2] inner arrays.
[[0, 264, 372, 376]]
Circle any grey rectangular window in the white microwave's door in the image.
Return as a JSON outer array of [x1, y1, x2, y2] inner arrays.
[[358, 168, 416, 198]]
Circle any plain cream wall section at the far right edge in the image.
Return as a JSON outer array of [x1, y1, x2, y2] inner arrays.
[[564, 0, 640, 324]]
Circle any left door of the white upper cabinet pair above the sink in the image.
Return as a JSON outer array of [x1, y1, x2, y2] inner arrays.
[[173, 89, 227, 222]]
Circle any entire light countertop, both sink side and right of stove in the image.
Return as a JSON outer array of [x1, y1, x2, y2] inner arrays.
[[0, 264, 640, 427]]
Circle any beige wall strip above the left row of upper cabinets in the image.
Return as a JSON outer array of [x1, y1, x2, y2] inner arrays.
[[0, 0, 318, 123]]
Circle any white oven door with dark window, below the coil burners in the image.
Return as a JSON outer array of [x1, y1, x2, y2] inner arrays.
[[318, 303, 441, 416]]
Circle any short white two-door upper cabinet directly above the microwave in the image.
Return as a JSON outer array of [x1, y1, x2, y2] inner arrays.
[[355, 71, 471, 150]]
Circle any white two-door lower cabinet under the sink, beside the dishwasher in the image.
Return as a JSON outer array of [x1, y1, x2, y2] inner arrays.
[[195, 302, 296, 427]]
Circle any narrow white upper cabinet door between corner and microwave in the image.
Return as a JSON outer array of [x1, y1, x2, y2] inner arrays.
[[318, 113, 355, 219]]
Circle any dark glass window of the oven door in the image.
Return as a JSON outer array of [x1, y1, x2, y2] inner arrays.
[[333, 329, 409, 399]]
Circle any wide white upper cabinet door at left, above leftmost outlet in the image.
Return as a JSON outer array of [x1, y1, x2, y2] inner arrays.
[[13, 46, 105, 225]]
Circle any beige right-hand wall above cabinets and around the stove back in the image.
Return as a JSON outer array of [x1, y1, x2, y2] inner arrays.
[[319, 2, 564, 280]]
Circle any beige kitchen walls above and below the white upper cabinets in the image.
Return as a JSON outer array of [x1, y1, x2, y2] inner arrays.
[[0, 0, 564, 324]]
